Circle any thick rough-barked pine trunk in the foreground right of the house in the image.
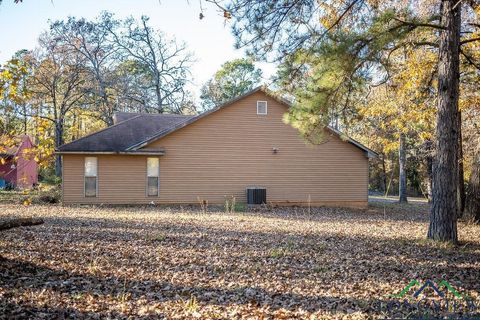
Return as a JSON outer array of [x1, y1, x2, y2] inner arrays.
[[428, 0, 462, 243]]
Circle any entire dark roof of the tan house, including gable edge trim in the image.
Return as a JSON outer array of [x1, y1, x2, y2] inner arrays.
[[58, 86, 378, 157]]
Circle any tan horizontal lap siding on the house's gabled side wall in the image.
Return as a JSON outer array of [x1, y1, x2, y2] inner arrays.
[[64, 92, 368, 206]]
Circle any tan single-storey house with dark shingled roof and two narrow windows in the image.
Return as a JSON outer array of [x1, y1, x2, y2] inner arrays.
[[58, 88, 375, 207]]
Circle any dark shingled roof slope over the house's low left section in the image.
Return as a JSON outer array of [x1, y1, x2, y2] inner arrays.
[[58, 112, 193, 154]]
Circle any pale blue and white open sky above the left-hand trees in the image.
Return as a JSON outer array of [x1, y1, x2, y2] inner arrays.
[[0, 0, 274, 96]]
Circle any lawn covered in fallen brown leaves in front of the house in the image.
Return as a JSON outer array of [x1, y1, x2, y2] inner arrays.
[[0, 203, 480, 319]]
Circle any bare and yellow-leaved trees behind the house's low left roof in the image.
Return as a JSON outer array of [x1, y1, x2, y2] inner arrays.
[[0, 12, 195, 175]]
